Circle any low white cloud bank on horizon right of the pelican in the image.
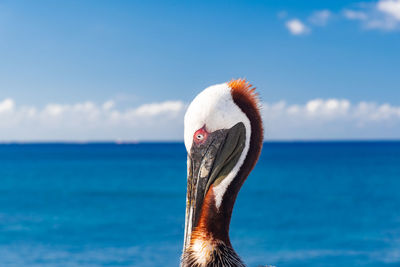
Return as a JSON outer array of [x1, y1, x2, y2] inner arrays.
[[263, 99, 400, 140]]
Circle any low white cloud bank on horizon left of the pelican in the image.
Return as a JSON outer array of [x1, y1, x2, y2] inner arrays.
[[0, 98, 185, 141]]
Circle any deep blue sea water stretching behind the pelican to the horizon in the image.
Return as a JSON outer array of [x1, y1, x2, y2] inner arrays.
[[0, 142, 400, 267]]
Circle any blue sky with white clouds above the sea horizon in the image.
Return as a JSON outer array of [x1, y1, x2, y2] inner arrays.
[[0, 0, 400, 142]]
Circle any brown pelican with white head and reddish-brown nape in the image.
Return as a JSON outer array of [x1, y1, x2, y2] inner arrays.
[[181, 79, 263, 267]]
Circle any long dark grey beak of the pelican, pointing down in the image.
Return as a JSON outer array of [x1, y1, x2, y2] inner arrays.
[[183, 123, 246, 251]]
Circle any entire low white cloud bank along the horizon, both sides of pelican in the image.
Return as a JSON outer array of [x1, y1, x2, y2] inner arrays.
[[0, 98, 400, 142]]
